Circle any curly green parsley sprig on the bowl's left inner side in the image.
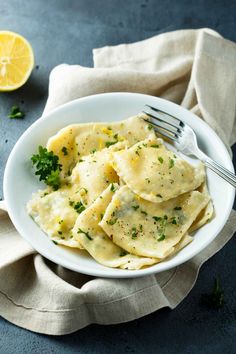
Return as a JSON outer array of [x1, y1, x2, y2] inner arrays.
[[31, 146, 62, 190]]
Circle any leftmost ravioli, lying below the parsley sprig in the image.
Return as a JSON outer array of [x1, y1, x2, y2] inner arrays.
[[27, 186, 84, 248]]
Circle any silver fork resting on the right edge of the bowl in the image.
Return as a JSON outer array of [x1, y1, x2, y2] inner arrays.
[[143, 105, 236, 188]]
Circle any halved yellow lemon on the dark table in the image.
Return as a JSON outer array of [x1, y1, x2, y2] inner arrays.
[[0, 31, 34, 91]]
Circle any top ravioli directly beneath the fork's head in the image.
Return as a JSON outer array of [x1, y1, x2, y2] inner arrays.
[[113, 137, 205, 203]]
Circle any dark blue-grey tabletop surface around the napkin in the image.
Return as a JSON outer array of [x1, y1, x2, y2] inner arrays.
[[0, 0, 236, 354]]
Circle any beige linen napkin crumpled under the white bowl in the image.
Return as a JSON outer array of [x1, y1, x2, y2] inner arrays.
[[0, 29, 236, 335]]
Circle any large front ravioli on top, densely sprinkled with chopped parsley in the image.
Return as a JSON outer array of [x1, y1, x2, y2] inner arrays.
[[99, 186, 209, 259]]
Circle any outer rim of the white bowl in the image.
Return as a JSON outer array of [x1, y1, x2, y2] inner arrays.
[[3, 92, 235, 278]]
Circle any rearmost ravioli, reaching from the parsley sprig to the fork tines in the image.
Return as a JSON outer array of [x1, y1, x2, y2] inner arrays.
[[47, 114, 155, 178]]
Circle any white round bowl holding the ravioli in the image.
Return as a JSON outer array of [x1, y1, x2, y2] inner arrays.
[[4, 93, 235, 278]]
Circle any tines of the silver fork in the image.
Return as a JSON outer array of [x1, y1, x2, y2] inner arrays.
[[143, 104, 184, 141]]
